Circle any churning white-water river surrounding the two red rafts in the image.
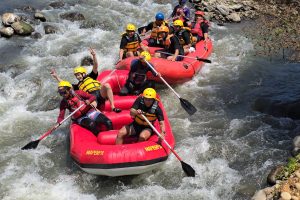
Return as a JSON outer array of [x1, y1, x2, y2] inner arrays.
[[0, 0, 300, 200]]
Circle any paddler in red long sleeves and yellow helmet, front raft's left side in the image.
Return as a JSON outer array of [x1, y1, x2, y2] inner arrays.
[[57, 81, 113, 136]]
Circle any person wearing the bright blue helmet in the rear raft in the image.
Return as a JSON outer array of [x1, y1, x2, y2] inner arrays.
[[141, 12, 169, 47]]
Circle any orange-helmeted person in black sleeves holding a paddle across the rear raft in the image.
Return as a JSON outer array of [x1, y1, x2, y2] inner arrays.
[[154, 26, 184, 61]]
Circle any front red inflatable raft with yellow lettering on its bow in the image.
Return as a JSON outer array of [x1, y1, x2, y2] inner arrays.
[[70, 70, 175, 176]]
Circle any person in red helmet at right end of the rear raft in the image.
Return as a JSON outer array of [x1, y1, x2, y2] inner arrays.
[[191, 11, 209, 42]]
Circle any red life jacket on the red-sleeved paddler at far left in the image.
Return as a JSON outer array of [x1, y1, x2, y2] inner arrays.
[[66, 95, 90, 120]]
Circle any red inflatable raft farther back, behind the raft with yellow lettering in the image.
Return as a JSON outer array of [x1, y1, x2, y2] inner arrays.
[[116, 39, 213, 84]]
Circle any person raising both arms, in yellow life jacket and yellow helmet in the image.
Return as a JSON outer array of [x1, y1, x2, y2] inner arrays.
[[50, 48, 121, 113]]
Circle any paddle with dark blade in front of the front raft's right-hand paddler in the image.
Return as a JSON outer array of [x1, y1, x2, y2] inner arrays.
[[141, 114, 195, 177]]
